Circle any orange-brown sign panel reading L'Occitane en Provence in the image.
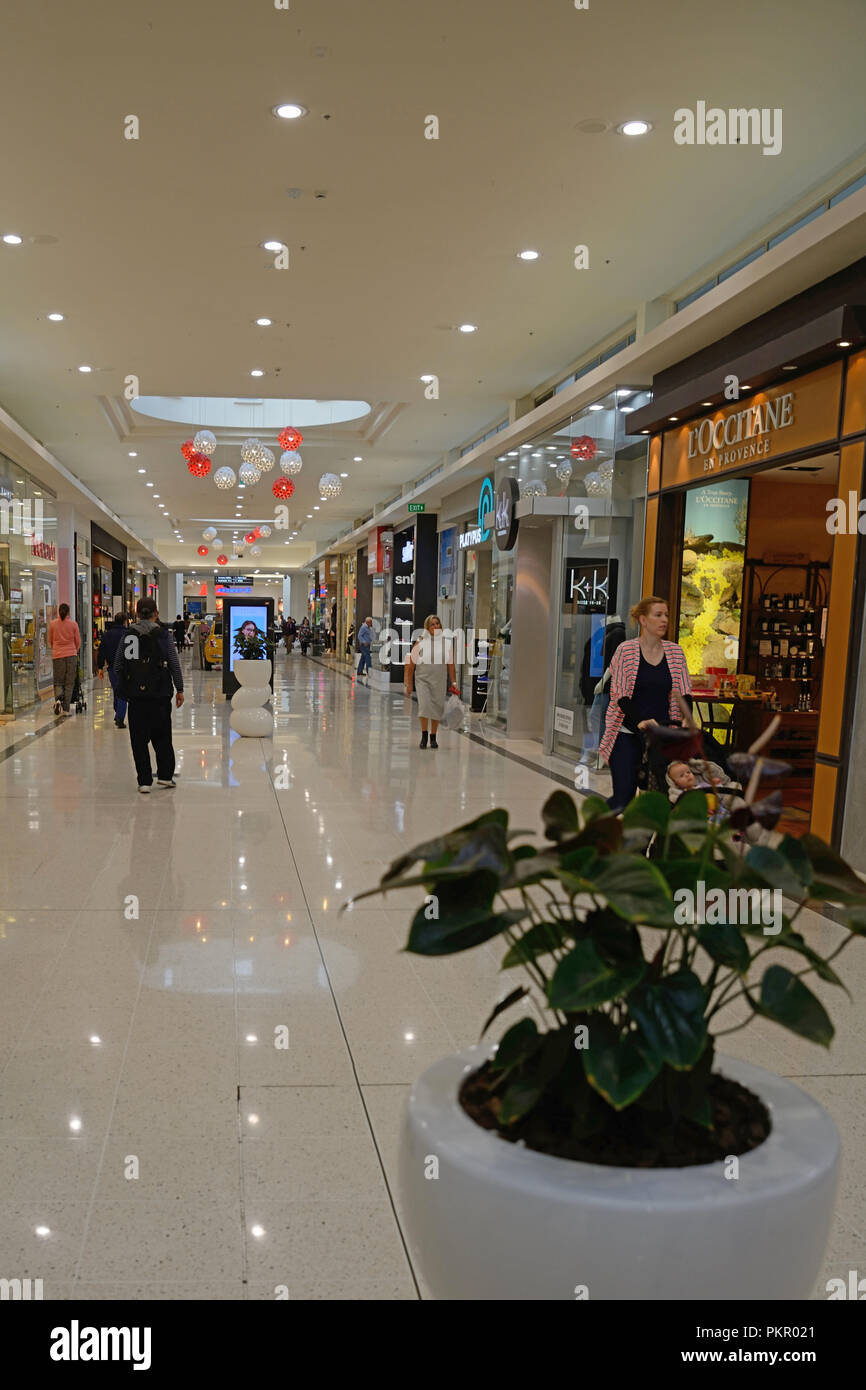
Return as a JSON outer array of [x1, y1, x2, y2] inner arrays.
[[662, 361, 842, 488]]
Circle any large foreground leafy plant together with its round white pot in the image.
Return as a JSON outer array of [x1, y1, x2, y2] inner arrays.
[[353, 728, 866, 1300]]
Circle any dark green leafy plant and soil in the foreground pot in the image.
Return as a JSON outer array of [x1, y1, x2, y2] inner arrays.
[[347, 728, 866, 1166]]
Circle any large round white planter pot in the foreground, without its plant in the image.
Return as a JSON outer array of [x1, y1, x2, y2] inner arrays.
[[400, 1047, 840, 1300]]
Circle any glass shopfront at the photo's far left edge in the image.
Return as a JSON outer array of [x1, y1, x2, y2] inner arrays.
[[0, 455, 57, 719]]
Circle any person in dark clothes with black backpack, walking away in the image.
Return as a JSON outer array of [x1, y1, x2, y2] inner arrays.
[[114, 599, 183, 792]]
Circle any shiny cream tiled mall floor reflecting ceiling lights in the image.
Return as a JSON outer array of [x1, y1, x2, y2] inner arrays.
[[0, 652, 866, 1300]]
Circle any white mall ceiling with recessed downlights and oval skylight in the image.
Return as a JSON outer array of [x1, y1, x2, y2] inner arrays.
[[0, 0, 866, 569]]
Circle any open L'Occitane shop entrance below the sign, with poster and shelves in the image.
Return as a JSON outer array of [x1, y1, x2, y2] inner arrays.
[[662, 453, 840, 835]]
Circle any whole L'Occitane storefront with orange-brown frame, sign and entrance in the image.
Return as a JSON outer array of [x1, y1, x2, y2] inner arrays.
[[635, 344, 866, 845]]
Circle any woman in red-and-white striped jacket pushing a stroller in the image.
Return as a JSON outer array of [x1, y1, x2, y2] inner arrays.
[[599, 595, 691, 810]]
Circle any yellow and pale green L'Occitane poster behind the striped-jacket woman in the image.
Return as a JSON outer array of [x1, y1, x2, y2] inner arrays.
[[677, 478, 749, 674]]
